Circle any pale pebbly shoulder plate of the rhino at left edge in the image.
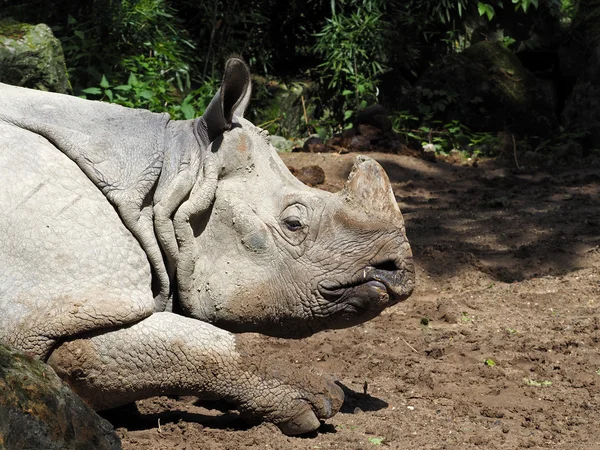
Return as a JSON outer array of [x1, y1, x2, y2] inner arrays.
[[0, 122, 154, 358]]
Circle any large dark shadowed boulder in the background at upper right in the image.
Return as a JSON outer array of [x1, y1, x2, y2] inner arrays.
[[402, 42, 558, 136]]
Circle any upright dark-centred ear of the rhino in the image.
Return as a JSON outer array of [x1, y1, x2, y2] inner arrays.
[[202, 58, 252, 142]]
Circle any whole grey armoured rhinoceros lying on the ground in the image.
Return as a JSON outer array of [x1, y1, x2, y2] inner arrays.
[[0, 59, 414, 434]]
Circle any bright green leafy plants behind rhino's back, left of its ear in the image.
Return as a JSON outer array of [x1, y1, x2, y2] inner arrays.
[[72, 0, 206, 118]]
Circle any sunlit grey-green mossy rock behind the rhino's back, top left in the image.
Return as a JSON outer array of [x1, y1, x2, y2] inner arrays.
[[0, 20, 72, 94]]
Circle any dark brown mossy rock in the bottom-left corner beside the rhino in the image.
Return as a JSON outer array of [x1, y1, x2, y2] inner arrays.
[[0, 344, 121, 450]]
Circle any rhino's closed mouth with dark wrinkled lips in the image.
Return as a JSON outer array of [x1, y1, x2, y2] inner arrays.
[[318, 266, 413, 311]]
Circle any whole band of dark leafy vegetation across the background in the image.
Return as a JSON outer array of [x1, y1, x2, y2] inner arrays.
[[0, 0, 600, 159]]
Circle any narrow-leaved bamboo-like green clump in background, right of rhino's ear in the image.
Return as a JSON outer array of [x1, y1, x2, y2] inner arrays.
[[314, 0, 386, 126]]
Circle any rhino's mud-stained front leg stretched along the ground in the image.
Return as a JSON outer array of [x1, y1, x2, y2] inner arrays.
[[48, 313, 343, 434]]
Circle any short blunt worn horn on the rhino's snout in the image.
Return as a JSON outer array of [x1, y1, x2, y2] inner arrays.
[[342, 156, 402, 221]]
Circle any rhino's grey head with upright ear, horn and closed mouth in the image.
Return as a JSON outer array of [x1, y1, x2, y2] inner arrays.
[[178, 60, 414, 337]]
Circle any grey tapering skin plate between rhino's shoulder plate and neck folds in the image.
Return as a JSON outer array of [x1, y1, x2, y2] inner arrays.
[[0, 84, 169, 308]]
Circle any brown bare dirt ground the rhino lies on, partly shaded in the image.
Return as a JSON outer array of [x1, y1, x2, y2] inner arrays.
[[110, 153, 600, 450]]
